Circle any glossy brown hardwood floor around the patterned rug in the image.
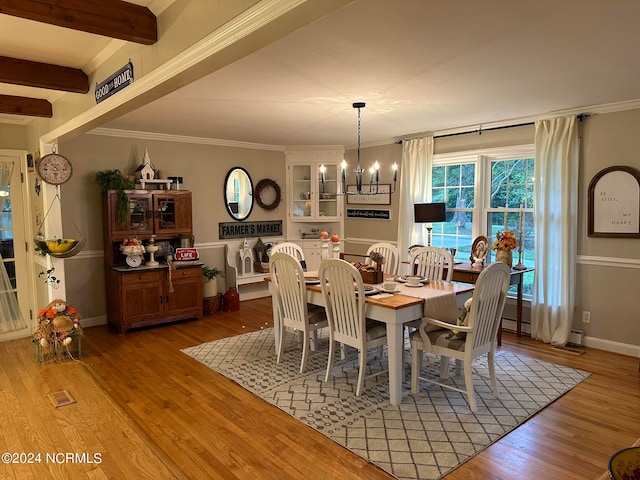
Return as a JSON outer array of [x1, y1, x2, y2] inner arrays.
[[0, 299, 640, 480]]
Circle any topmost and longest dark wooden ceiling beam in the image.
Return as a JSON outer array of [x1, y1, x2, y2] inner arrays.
[[0, 0, 158, 47]]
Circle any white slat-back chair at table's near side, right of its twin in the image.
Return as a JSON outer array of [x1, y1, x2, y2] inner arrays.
[[318, 258, 388, 396]]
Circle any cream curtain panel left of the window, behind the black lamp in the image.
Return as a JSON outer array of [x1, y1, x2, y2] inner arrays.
[[398, 137, 433, 258]]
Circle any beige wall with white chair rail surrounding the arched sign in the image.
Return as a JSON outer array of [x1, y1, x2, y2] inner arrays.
[[574, 110, 640, 355]]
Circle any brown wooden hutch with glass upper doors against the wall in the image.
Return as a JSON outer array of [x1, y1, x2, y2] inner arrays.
[[103, 190, 202, 333]]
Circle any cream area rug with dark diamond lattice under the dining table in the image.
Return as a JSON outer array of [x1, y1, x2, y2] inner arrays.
[[182, 328, 589, 480]]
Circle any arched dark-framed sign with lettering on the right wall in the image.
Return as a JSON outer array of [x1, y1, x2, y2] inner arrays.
[[587, 165, 640, 238]]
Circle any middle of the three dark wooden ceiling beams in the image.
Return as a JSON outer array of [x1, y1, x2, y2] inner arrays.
[[0, 56, 89, 93]]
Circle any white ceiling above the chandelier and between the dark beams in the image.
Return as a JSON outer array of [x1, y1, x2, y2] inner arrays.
[[0, 0, 640, 146]]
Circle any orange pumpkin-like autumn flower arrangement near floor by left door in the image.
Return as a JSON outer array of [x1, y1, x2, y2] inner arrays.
[[33, 300, 82, 359]]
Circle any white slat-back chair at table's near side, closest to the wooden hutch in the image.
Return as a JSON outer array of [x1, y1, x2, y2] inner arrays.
[[269, 252, 328, 373]]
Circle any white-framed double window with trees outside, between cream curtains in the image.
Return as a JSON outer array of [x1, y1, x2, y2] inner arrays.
[[431, 146, 535, 298]]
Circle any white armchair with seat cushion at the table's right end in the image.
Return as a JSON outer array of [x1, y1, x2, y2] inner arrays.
[[410, 262, 511, 412]]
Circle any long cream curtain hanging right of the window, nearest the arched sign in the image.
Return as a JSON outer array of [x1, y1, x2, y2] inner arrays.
[[531, 116, 579, 345]]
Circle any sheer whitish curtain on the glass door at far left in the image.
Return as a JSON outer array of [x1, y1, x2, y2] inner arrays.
[[0, 162, 27, 333]]
